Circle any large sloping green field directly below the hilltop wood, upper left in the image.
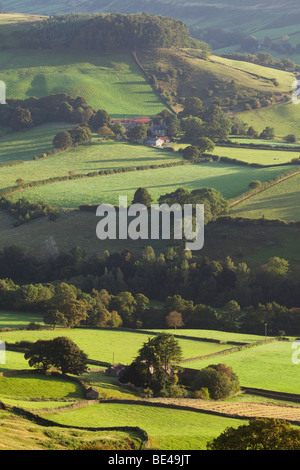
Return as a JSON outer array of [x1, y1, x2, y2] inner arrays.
[[1, 50, 166, 118]]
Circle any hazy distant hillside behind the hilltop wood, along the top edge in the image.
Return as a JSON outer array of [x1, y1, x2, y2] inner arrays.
[[1, 0, 300, 63]]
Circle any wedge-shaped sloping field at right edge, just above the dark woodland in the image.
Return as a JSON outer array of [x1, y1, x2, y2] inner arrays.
[[230, 175, 300, 222]]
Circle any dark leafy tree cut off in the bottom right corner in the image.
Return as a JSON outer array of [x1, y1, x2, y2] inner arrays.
[[207, 418, 300, 451]]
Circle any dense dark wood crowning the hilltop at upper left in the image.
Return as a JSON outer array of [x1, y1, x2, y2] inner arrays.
[[23, 13, 208, 52]]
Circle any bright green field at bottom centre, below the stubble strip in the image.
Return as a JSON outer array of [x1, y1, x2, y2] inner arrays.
[[42, 403, 243, 450]]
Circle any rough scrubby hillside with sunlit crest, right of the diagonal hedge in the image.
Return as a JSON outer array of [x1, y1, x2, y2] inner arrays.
[[137, 48, 294, 113]]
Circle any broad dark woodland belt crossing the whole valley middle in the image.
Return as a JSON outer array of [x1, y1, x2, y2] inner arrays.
[[0, 242, 300, 335]]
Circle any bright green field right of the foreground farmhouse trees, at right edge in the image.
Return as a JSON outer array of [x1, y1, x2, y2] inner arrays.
[[186, 341, 300, 393]]
